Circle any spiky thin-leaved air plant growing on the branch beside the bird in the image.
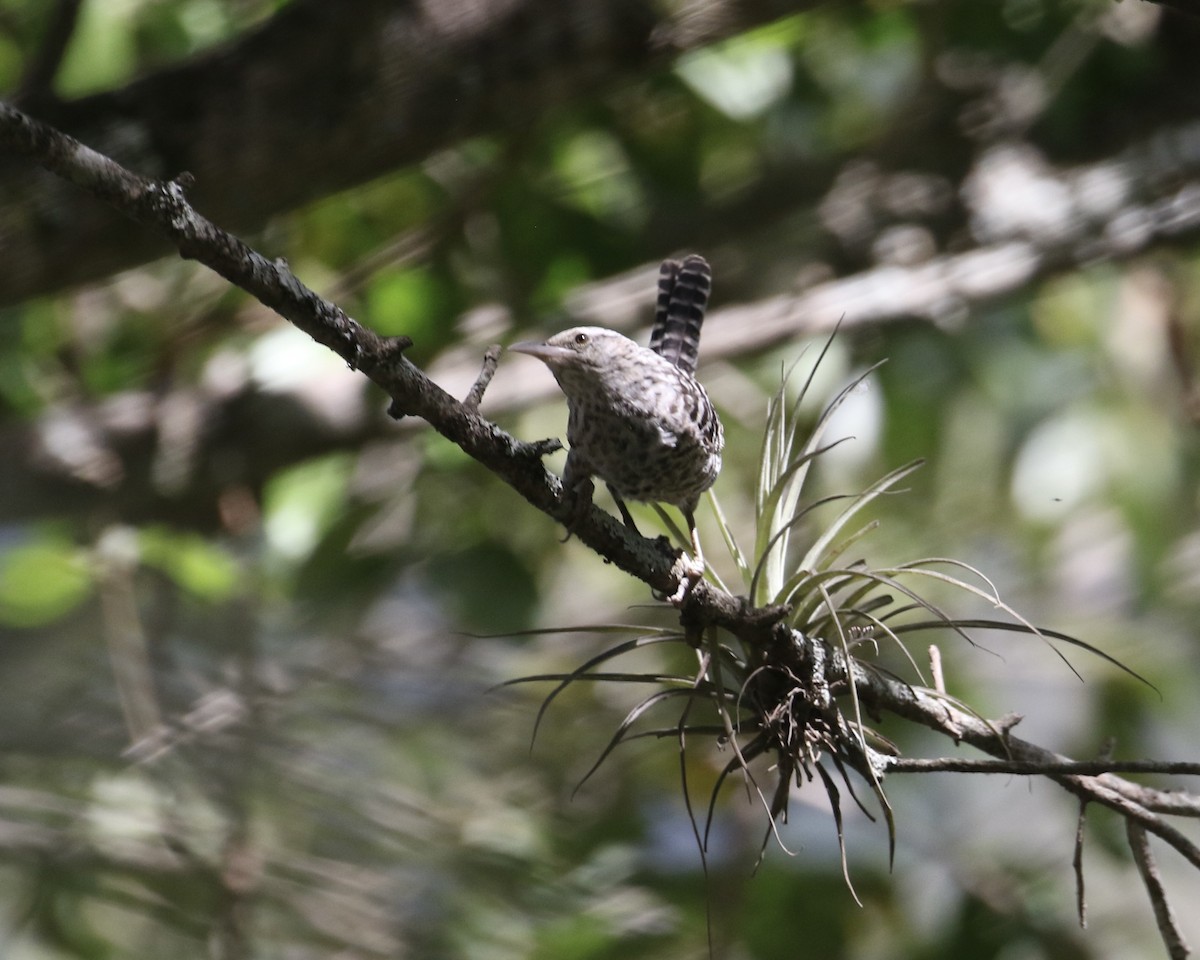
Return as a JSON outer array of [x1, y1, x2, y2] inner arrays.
[[505, 338, 1141, 899]]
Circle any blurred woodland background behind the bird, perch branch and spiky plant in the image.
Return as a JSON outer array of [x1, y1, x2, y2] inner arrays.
[[0, 0, 1200, 960]]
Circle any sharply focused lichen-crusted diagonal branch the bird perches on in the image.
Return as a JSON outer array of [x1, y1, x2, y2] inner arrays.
[[0, 104, 1200, 960]]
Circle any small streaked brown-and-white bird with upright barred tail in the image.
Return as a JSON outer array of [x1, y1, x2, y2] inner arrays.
[[509, 254, 725, 590]]
